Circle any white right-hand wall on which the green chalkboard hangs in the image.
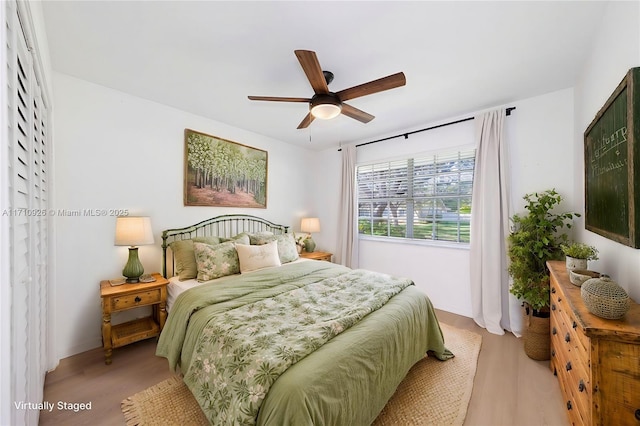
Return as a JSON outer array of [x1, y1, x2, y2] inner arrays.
[[573, 2, 640, 302]]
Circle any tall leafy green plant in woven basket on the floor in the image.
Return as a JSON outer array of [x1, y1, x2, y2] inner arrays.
[[507, 189, 579, 360]]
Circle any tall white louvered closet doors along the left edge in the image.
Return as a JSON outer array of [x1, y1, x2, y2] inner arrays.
[[0, 1, 50, 425]]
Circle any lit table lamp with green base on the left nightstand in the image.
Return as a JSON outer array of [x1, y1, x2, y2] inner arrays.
[[115, 216, 153, 283]]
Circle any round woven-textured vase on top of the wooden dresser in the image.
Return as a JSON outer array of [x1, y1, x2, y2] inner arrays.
[[580, 275, 631, 319]]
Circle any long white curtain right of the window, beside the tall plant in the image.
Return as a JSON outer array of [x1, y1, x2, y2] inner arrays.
[[470, 109, 522, 336]]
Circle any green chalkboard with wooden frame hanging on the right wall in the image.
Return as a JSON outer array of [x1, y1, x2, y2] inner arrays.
[[584, 67, 640, 248]]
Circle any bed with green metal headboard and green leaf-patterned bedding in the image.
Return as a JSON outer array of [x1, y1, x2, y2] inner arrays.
[[156, 215, 453, 425]]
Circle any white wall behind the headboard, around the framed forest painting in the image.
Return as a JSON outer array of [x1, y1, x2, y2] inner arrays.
[[53, 73, 311, 358]]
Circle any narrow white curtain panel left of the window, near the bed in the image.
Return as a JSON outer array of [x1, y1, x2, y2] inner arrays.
[[336, 145, 358, 268]]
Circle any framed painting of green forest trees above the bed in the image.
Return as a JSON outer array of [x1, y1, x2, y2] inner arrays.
[[184, 129, 268, 209]]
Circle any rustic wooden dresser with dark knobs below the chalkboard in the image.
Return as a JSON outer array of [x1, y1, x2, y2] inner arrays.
[[547, 261, 640, 426]]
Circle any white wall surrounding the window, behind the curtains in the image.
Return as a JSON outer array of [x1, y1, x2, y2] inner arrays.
[[314, 89, 576, 316]]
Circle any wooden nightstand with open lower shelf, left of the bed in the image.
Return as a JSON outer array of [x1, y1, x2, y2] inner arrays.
[[100, 273, 169, 364]]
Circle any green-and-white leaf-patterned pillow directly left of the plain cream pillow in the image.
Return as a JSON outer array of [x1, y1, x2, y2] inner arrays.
[[193, 241, 240, 281]]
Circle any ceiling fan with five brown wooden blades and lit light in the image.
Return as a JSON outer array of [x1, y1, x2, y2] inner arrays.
[[249, 50, 407, 129]]
